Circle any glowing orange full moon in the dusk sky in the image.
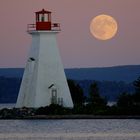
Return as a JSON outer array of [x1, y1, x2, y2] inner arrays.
[[90, 15, 118, 40]]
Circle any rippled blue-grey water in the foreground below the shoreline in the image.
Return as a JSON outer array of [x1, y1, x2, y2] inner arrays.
[[0, 119, 140, 140]]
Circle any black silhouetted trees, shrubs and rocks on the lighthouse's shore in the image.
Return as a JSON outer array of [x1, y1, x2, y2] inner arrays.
[[0, 77, 140, 118]]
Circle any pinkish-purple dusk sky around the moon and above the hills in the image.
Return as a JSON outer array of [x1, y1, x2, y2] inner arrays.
[[0, 0, 140, 68]]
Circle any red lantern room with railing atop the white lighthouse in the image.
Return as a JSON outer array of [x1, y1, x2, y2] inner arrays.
[[28, 9, 60, 31]]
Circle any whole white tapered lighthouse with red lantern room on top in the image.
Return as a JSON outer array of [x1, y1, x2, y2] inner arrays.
[[16, 9, 73, 108]]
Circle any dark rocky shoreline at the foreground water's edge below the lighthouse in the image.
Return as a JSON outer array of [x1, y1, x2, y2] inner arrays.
[[0, 108, 140, 120]]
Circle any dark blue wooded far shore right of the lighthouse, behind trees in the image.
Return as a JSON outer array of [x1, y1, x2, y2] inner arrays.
[[75, 80, 135, 102]]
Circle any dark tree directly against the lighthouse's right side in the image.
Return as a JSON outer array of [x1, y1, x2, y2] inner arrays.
[[68, 80, 84, 105]]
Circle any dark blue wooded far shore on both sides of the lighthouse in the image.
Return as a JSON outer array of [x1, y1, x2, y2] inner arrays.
[[0, 77, 135, 103]]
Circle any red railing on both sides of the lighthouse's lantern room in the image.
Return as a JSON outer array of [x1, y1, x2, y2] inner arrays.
[[27, 23, 61, 32]]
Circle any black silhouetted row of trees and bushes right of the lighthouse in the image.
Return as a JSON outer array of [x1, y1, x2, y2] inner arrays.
[[68, 77, 140, 115]]
